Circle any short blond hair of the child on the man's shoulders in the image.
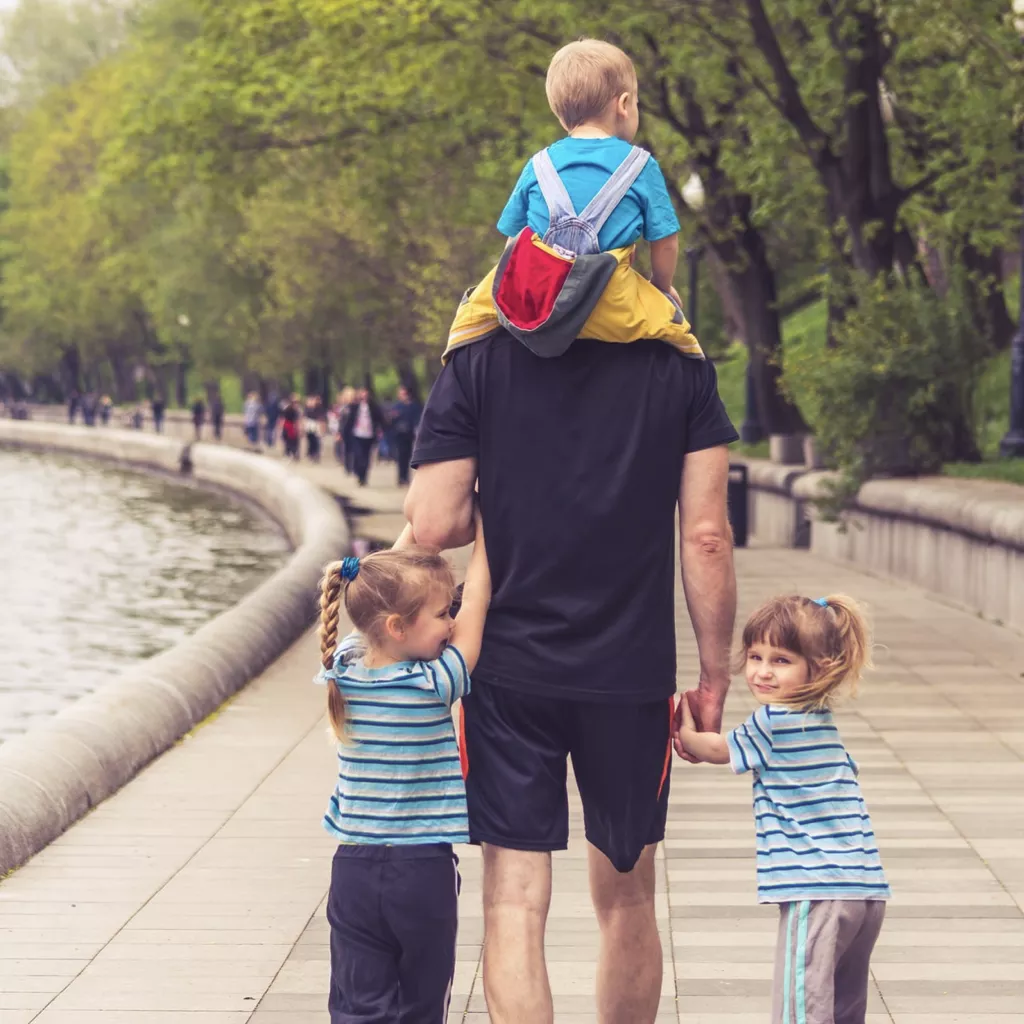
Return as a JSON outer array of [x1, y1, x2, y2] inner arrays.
[[547, 39, 637, 131]]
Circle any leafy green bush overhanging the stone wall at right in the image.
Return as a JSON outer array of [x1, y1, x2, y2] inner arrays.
[[782, 273, 989, 515]]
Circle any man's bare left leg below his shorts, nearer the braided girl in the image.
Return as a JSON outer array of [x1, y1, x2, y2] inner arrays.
[[483, 843, 552, 1024]]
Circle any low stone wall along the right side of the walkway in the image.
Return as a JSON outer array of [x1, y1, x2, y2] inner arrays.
[[748, 460, 1024, 630]]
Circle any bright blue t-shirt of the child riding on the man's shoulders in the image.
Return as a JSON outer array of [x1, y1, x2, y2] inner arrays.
[[498, 136, 679, 252]]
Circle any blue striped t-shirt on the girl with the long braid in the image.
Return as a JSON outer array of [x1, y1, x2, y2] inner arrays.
[[316, 633, 469, 846]]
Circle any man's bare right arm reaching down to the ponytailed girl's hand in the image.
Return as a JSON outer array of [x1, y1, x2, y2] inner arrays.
[[676, 444, 736, 756]]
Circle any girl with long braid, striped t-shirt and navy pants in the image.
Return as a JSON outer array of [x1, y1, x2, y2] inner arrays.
[[316, 515, 490, 1024]]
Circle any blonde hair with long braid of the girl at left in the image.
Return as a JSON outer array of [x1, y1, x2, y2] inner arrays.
[[319, 547, 455, 739]]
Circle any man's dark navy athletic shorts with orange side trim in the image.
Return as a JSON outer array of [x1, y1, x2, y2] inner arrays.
[[460, 682, 675, 871]]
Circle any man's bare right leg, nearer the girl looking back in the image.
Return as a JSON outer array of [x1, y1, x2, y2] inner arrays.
[[588, 845, 662, 1024]]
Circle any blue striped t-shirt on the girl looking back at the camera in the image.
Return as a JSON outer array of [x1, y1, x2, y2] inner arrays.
[[727, 705, 890, 903]]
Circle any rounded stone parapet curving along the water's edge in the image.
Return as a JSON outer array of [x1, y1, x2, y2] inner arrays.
[[0, 420, 349, 874]]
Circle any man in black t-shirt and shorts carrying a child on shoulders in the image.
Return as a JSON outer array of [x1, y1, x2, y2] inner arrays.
[[406, 333, 736, 1024]]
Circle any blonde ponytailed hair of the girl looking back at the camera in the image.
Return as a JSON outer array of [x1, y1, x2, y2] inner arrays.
[[734, 594, 871, 711]]
